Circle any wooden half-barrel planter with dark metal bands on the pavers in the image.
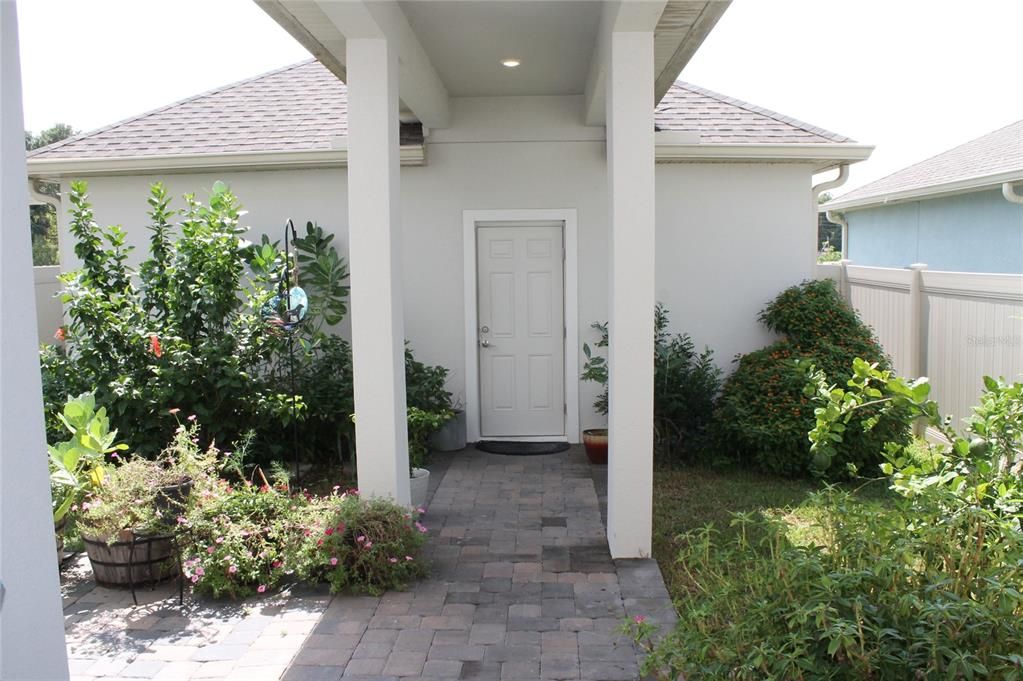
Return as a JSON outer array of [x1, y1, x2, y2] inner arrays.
[[82, 535, 180, 587]]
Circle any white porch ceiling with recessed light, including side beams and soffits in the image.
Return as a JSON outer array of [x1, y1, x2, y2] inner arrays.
[[254, 0, 730, 128]]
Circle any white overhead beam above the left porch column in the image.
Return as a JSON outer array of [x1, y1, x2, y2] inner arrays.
[[317, 0, 451, 128]]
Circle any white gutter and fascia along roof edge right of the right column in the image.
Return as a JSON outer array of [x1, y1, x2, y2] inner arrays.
[[655, 139, 874, 172]]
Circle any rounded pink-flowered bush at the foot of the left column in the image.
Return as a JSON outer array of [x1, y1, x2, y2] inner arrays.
[[299, 493, 427, 595]]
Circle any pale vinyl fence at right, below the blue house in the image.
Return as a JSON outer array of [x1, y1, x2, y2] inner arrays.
[[817, 261, 1023, 428]]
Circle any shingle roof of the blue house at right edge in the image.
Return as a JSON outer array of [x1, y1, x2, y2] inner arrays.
[[835, 121, 1023, 202]]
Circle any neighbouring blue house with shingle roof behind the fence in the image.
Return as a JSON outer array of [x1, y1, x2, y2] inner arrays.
[[819, 121, 1023, 274]]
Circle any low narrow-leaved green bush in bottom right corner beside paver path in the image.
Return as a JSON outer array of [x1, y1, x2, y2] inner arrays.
[[630, 491, 1023, 681]]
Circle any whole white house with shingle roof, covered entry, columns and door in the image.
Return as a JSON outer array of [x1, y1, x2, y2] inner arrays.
[[18, 0, 871, 557]]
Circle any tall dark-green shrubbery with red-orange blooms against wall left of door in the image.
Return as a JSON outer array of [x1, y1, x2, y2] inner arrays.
[[41, 182, 451, 464]]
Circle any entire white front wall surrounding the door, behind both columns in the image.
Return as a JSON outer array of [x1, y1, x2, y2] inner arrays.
[[51, 97, 815, 440]]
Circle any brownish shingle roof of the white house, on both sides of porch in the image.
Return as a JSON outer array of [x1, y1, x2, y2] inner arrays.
[[29, 60, 852, 158]]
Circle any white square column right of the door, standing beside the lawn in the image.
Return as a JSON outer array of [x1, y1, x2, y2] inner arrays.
[[607, 31, 655, 558]]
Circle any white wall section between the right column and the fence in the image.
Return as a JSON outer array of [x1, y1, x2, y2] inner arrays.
[[657, 164, 816, 371]]
